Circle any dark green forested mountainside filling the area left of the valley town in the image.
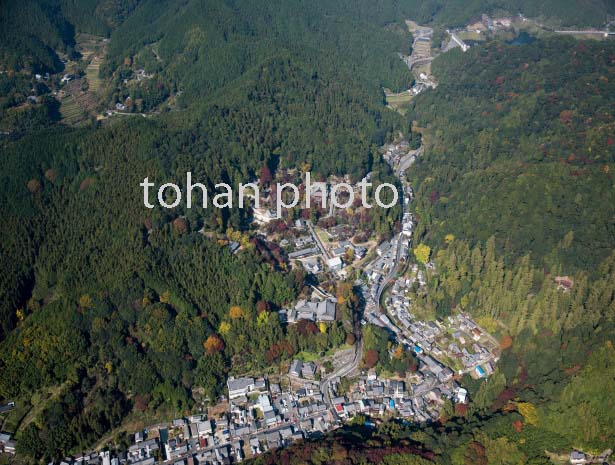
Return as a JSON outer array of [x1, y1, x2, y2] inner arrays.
[[0, 1, 411, 461]]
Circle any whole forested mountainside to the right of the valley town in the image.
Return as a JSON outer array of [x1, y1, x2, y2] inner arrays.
[[238, 32, 615, 465]]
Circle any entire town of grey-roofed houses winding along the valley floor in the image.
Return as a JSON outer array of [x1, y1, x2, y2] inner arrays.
[[0, 139, 506, 465]]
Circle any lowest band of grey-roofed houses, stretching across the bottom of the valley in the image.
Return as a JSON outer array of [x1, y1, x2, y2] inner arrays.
[[26, 358, 474, 465]]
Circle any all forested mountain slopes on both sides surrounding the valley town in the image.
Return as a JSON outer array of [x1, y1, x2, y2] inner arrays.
[[0, 0, 615, 464]]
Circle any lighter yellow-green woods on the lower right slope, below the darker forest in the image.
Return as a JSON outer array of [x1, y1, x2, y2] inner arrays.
[[251, 239, 615, 465]]
